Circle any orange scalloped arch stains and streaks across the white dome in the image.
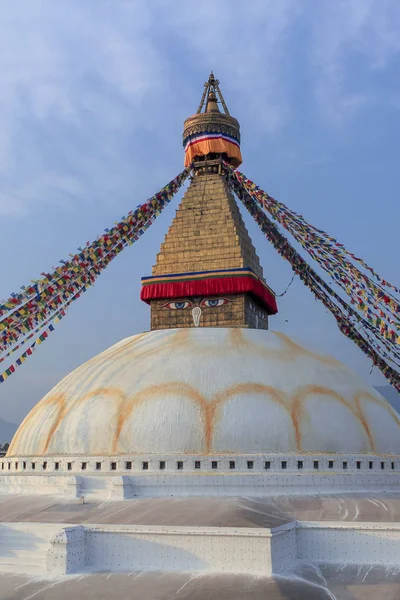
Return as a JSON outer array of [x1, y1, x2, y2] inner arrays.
[[7, 342, 400, 456]]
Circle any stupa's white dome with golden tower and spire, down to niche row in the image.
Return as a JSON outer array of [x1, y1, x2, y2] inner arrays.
[[2, 74, 400, 468]]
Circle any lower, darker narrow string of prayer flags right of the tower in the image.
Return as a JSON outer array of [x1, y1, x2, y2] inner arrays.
[[228, 167, 400, 392]]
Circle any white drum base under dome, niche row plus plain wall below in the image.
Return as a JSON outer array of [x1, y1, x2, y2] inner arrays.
[[0, 453, 400, 500]]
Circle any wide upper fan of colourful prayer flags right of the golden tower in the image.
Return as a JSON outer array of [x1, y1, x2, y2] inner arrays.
[[227, 165, 400, 353]]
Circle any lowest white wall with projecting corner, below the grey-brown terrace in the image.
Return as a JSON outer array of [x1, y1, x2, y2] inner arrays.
[[51, 521, 400, 575]]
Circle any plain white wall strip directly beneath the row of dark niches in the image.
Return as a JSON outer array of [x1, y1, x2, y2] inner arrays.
[[0, 470, 400, 500]]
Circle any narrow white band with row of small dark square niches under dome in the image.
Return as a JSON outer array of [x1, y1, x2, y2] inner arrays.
[[0, 452, 400, 476]]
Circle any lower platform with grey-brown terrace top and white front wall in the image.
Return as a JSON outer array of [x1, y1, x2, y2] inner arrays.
[[0, 493, 400, 580]]
